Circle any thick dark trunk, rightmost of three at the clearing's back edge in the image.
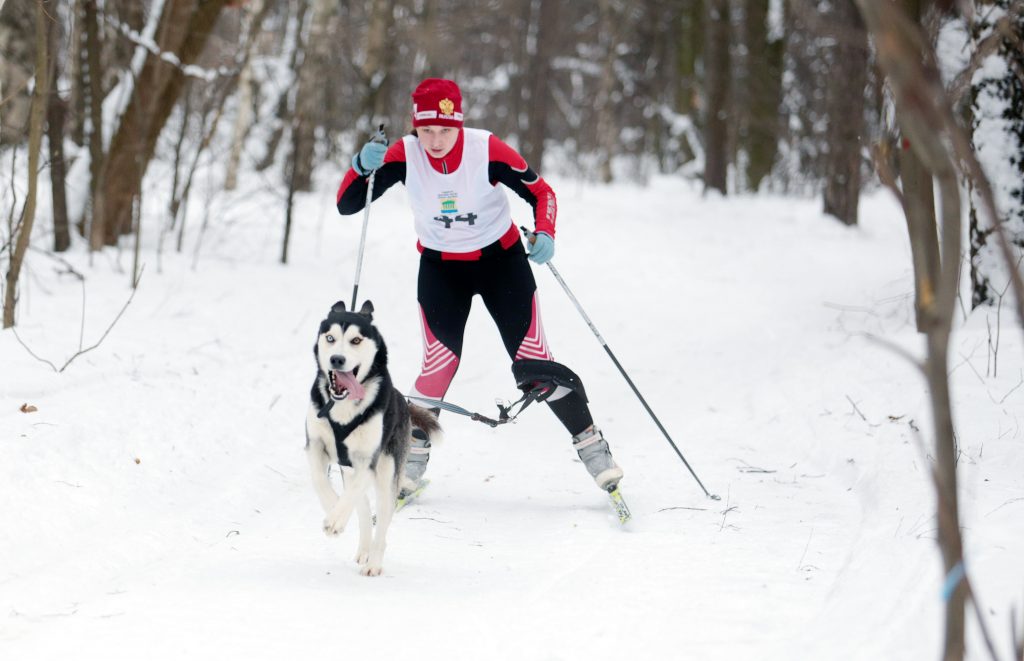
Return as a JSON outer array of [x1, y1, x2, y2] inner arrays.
[[824, 0, 867, 225]]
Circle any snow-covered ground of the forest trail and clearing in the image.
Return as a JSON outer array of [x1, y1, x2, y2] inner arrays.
[[0, 171, 1024, 660]]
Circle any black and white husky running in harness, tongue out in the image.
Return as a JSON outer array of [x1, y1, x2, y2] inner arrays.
[[306, 301, 440, 576]]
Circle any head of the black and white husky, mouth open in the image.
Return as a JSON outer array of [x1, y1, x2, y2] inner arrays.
[[313, 301, 384, 401]]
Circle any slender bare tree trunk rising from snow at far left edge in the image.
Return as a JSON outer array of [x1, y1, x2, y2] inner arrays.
[[3, 2, 49, 328]]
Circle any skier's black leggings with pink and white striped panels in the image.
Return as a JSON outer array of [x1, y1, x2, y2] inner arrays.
[[413, 244, 594, 436]]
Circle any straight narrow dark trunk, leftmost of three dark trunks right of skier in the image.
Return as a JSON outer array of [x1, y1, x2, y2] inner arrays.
[[705, 0, 731, 195]]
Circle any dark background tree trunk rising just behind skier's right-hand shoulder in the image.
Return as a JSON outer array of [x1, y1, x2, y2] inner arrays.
[[521, 0, 559, 172]]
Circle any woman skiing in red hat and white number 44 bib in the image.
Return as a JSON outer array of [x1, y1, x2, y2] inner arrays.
[[338, 78, 623, 492]]
